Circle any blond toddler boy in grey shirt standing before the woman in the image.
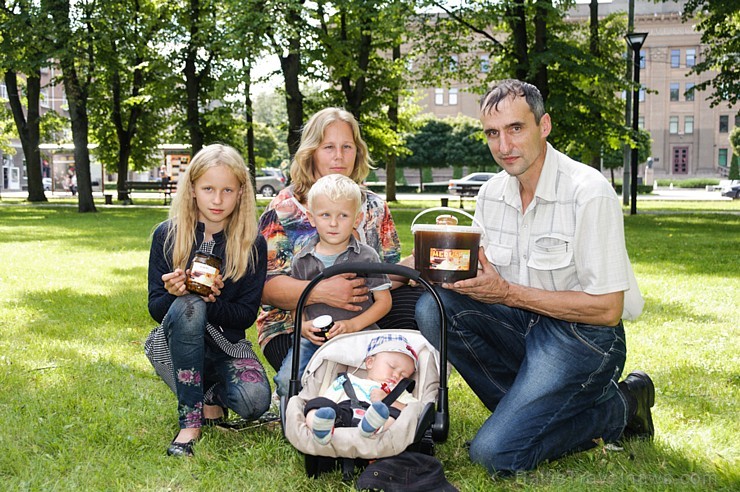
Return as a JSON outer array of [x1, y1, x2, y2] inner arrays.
[[275, 174, 391, 394]]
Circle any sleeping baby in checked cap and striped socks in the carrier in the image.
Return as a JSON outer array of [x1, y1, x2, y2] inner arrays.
[[303, 334, 418, 444]]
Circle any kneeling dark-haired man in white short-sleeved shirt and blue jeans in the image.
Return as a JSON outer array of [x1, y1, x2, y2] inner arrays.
[[416, 80, 655, 475]]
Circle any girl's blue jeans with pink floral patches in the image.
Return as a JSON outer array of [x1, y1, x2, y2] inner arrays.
[[162, 295, 270, 429]]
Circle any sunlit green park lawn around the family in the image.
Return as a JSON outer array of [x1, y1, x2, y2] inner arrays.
[[0, 200, 740, 491]]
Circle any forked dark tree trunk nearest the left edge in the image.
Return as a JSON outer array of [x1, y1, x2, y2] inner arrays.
[[5, 69, 48, 202]]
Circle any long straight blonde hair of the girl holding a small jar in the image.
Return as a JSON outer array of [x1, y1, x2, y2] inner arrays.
[[164, 144, 257, 281]]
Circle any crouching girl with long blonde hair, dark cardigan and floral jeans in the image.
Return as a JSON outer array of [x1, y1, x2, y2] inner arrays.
[[145, 145, 270, 456]]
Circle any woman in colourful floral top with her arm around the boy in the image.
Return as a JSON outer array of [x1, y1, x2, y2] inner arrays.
[[257, 108, 420, 396]]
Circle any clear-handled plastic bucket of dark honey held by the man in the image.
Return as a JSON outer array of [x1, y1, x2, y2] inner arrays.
[[411, 207, 483, 283]]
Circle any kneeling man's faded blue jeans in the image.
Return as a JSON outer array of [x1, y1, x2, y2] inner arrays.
[[416, 288, 627, 474]]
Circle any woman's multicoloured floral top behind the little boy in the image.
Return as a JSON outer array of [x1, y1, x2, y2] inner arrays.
[[257, 186, 401, 346]]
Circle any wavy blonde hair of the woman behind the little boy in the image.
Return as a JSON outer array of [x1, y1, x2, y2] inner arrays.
[[290, 108, 372, 203]]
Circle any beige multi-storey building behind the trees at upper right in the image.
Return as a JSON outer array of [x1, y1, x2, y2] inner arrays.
[[419, 0, 740, 179]]
